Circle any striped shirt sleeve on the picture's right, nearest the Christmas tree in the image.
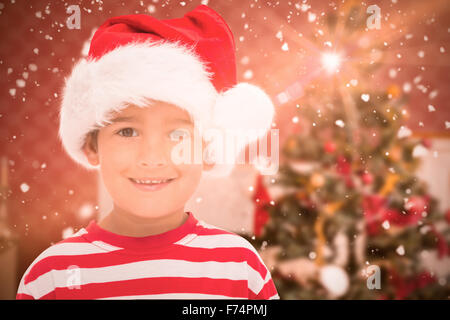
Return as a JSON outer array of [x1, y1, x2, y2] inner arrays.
[[247, 242, 280, 300]]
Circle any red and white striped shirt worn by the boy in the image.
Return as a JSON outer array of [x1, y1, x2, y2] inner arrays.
[[16, 212, 279, 299]]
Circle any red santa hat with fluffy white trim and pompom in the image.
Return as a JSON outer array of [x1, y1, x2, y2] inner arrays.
[[59, 5, 274, 176]]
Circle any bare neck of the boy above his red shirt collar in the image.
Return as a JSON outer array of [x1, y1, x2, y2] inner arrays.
[[98, 208, 188, 237]]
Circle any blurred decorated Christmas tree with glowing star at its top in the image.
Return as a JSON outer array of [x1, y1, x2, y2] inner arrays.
[[242, 5, 450, 299]]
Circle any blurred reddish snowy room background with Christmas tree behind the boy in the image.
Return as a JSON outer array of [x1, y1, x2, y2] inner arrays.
[[0, 0, 450, 299]]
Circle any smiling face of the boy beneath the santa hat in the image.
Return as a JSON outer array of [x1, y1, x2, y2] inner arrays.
[[83, 101, 210, 218]]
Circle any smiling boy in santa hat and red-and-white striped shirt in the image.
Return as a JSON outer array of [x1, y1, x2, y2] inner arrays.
[[17, 5, 279, 299]]
